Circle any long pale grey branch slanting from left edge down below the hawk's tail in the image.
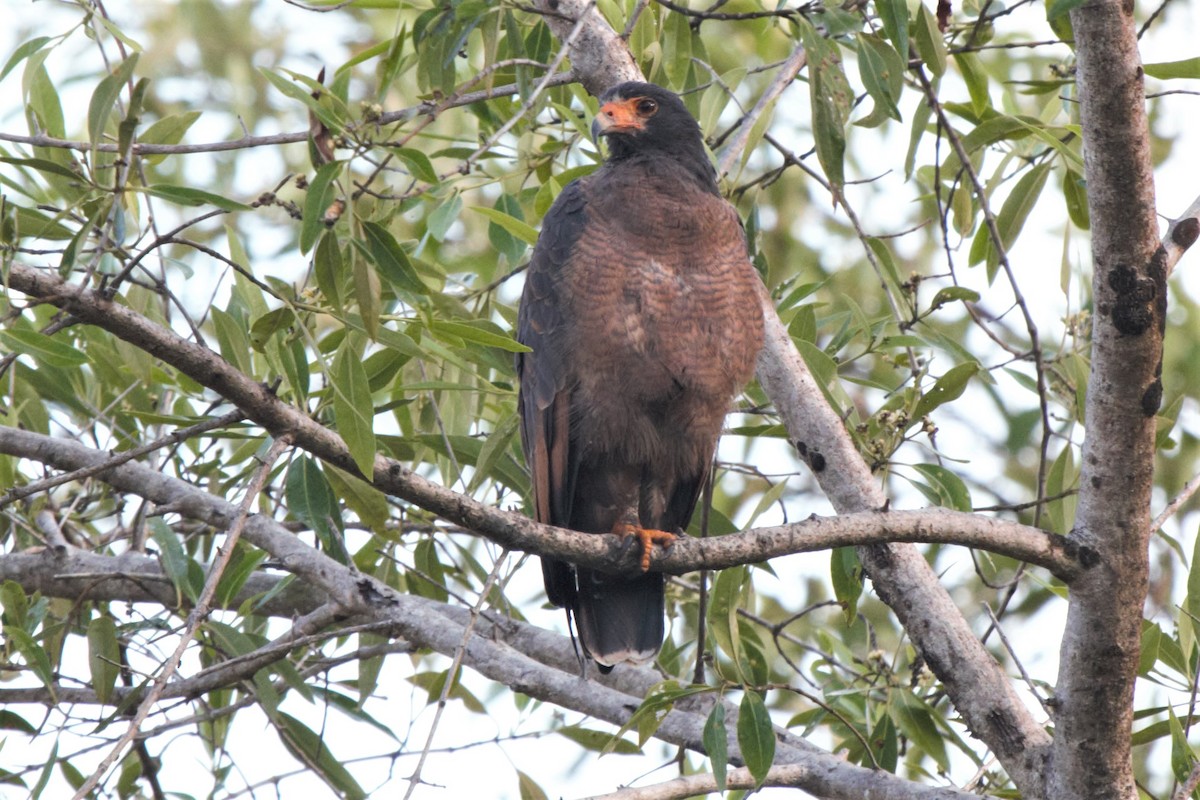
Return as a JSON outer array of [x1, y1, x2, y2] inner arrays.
[[0, 428, 970, 800]]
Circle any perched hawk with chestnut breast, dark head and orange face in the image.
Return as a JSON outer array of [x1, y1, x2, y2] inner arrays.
[[517, 83, 762, 672]]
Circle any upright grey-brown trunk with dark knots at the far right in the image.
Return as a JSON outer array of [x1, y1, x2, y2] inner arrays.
[[1048, 0, 1166, 800]]
